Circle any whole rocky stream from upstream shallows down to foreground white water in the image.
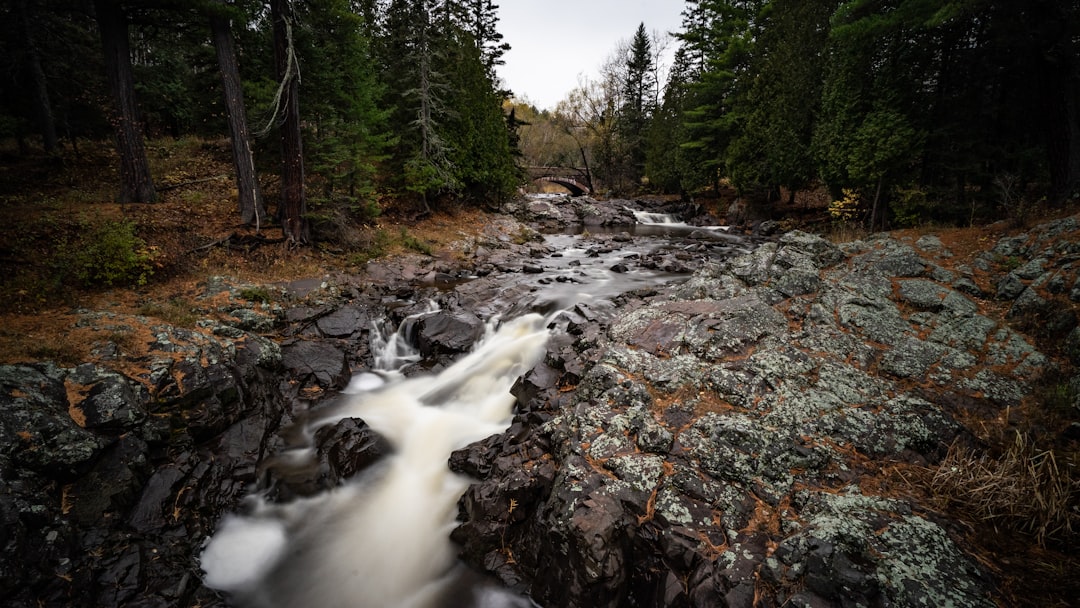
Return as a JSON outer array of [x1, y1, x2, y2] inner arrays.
[[201, 197, 751, 608]]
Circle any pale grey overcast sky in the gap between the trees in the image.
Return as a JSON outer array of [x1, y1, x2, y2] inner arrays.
[[498, 0, 686, 109]]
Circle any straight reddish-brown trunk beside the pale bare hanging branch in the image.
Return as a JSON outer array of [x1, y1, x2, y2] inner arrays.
[[270, 0, 309, 247]]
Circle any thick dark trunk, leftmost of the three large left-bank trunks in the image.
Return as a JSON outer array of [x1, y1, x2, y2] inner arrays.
[[94, 0, 158, 203]]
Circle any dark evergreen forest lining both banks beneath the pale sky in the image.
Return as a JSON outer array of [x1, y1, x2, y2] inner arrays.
[[0, 0, 1080, 245]]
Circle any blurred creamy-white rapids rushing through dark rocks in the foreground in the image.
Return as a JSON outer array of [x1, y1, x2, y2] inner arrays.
[[201, 314, 549, 608]]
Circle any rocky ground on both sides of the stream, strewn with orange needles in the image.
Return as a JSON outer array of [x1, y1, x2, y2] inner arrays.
[[0, 199, 1080, 607]]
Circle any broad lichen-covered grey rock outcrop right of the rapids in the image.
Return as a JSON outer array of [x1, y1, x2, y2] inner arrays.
[[453, 222, 1067, 606]]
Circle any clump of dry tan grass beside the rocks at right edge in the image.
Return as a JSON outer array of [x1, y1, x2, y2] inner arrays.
[[919, 433, 1080, 546]]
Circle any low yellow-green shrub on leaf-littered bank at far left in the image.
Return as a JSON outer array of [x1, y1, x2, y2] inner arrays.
[[58, 219, 156, 287]]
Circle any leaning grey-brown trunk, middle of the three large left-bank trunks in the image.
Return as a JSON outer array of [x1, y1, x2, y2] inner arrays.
[[210, 10, 267, 230]]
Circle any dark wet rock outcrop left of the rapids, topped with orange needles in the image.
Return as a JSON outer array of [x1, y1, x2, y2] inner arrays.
[[0, 312, 284, 608]]
